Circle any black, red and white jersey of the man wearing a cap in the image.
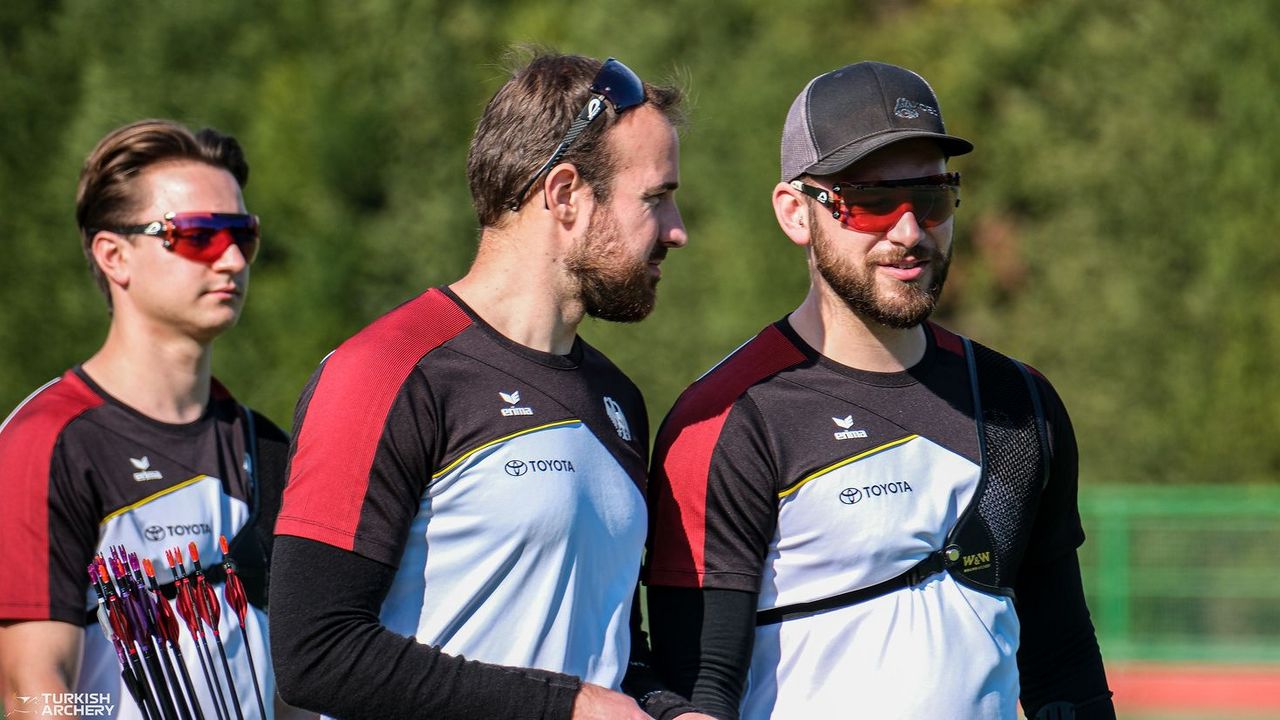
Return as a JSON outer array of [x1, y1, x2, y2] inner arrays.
[[646, 320, 1083, 719]]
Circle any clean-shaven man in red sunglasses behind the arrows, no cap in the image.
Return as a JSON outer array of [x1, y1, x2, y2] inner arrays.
[[0, 120, 304, 717]]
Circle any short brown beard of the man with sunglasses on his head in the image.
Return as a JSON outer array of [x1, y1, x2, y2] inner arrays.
[[564, 206, 667, 323]]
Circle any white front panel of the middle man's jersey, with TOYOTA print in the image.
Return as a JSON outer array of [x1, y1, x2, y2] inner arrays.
[[381, 420, 648, 688]]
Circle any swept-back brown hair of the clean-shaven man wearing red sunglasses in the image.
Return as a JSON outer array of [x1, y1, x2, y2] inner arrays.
[[76, 120, 248, 307]]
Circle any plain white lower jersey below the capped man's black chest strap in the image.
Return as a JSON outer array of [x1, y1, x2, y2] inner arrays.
[[741, 573, 1019, 720]]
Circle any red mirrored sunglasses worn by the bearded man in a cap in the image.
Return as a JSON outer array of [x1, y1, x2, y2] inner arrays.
[[791, 173, 960, 233]]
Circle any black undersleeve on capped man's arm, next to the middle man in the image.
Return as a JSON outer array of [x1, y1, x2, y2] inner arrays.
[[649, 587, 756, 720]]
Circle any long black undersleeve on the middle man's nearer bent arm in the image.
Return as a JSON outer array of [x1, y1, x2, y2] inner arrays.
[[270, 536, 581, 720]]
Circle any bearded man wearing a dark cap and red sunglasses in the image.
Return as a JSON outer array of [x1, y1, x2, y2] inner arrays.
[[645, 63, 1115, 720]]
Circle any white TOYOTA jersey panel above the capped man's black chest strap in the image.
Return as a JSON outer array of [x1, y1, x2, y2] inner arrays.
[[759, 436, 980, 610]]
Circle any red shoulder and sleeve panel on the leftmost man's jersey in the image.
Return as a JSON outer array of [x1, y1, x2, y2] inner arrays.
[[0, 370, 102, 620]]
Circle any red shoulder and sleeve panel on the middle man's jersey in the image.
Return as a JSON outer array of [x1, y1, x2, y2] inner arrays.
[[275, 288, 471, 550]]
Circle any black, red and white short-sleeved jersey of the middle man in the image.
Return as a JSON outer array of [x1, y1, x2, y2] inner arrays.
[[276, 283, 648, 687]]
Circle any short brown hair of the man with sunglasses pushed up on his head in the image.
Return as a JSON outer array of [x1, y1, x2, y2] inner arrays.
[[467, 49, 684, 227]]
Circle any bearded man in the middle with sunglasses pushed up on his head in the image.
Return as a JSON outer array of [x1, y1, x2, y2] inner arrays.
[[271, 54, 711, 720]]
